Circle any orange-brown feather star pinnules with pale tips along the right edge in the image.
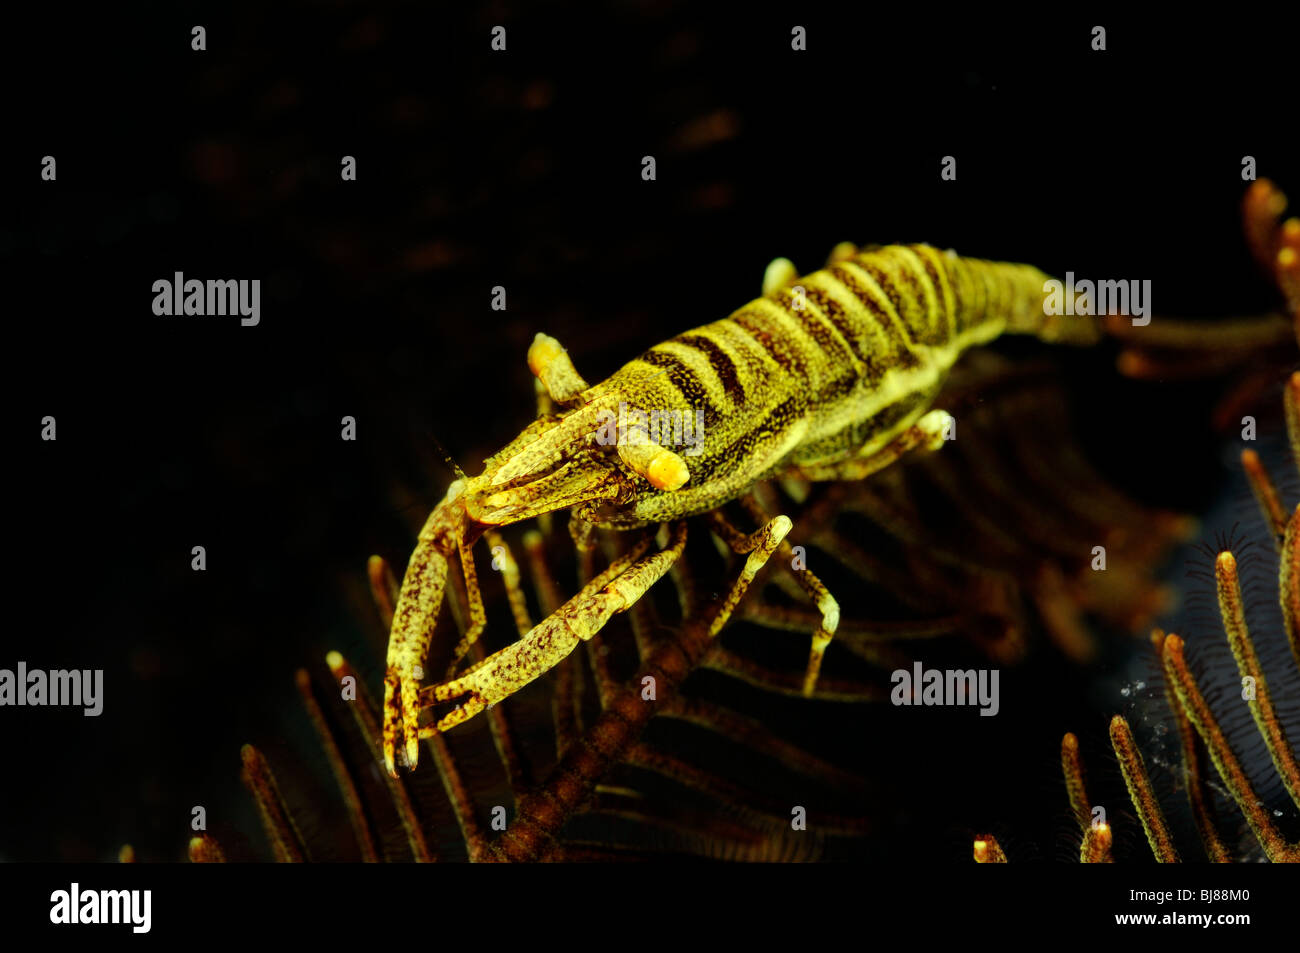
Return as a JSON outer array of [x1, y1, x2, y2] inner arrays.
[[975, 179, 1300, 863]]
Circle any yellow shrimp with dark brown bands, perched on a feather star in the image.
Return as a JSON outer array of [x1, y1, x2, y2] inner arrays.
[[384, 244, 1099, 775]]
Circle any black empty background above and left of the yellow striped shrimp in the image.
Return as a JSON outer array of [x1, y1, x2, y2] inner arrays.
[[0, 3, 1300, 861]]
